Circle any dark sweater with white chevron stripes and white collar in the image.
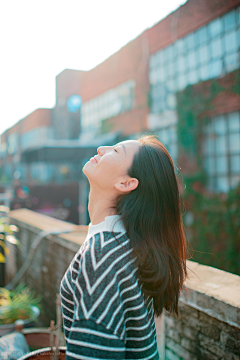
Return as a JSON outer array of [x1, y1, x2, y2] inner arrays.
[[60, 215, 159, 360]]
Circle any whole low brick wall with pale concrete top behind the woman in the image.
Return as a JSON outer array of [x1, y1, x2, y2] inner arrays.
[[6, 209, 240, 360]]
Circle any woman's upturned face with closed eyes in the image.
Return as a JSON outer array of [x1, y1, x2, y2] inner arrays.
[[83, 140, 140, 189]]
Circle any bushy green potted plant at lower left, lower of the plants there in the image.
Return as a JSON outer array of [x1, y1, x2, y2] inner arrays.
[[0, 283, 42, 325]]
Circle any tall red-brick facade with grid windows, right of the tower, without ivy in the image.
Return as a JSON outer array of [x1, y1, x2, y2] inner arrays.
[[77, 0, 240, 192]]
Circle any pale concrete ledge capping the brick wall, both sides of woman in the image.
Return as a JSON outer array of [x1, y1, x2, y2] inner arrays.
[[8, 209, 240, 329]]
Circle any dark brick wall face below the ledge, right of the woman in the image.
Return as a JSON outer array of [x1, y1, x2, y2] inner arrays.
[[165, 302, 240, 360]]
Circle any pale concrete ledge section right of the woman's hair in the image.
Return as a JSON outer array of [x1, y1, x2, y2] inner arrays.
[[180, 261, 240, 329]]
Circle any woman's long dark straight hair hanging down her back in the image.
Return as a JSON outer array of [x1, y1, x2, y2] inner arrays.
[[117, 136, 187, 316]]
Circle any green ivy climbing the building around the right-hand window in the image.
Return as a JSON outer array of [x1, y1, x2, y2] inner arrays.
[[177, 70, 240, 275]]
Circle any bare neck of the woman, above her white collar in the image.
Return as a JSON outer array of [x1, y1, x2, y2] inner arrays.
[[88, 188, 117, 225]]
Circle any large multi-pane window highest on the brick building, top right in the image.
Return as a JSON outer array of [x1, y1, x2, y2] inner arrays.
[[149, 7, 240, 112]]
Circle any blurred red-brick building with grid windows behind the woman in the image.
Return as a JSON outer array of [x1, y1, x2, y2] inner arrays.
[[0, 0, 240, 274]]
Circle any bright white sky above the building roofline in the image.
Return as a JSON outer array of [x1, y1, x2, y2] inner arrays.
[[0, 0, 186, 134]]
